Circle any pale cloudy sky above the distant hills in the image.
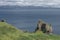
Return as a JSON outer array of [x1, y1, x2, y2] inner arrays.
[[0, 0, 60, 7]]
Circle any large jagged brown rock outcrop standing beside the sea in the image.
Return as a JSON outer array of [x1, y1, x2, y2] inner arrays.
[[35, 20, 52, 34]]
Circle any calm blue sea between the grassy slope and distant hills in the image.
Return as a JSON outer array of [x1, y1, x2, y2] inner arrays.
[[0, 7, 60, 34]]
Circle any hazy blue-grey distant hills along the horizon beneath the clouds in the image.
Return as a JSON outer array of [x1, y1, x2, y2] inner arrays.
[[0, 6, 59, 9]]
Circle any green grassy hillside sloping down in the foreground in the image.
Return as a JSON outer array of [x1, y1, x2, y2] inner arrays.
[[0, 22, 60, 40]]
